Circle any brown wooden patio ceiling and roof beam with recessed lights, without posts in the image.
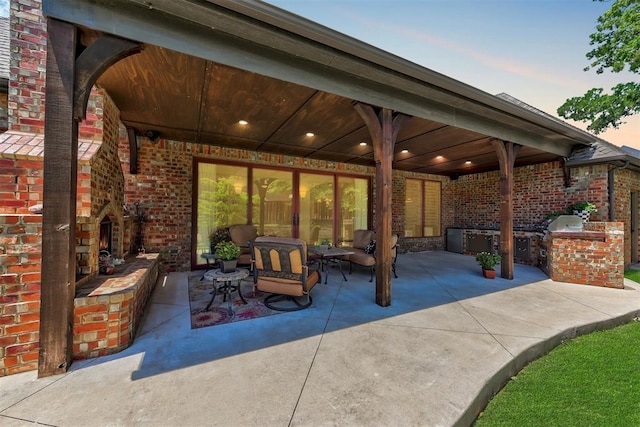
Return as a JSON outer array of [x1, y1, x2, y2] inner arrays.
[[43, 0, 596, 175]]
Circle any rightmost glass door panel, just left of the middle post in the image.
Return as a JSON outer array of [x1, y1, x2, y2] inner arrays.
[[337, 176, 369, 244]]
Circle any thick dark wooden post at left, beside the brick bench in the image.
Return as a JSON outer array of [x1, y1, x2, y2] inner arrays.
[[38, 19, 78, 377]]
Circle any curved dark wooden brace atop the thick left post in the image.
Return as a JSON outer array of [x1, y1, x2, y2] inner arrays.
[[73, 35, 142, 120]]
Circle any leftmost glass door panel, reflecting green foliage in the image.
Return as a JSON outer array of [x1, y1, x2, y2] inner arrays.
[[196, 163, 249, 263]]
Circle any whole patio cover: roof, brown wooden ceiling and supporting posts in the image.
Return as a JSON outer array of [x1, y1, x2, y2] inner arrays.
[[39, 0, 591, 376]]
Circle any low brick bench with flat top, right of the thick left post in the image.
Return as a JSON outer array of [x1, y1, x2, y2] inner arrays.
[[73, 254, 159, 359]]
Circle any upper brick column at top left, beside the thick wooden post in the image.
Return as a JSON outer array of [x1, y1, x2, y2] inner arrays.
[[8, 0, 47, 134]]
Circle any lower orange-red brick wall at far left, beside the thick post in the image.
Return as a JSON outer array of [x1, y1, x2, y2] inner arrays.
[[0, 215, 42, 376]]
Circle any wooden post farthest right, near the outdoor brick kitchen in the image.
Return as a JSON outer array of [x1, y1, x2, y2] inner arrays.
[[491, 139, 520, 279]]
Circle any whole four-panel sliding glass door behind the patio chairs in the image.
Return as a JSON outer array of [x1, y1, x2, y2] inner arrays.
[[192, 161, 370, 267]]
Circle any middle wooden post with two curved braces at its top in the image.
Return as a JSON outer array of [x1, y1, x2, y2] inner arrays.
[[354, 103, 408, 307]]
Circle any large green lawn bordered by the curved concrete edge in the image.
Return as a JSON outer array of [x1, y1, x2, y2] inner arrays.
[[474, 322, 640, 427]]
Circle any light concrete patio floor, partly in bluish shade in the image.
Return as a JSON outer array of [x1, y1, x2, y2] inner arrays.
[[0, 252, 640, 427]]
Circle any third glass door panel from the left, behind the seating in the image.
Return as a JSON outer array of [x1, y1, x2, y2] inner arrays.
[[298, 173, 334, 245]]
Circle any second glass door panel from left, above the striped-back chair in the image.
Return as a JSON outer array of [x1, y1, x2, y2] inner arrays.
[[252, 168, 293, 237]]
